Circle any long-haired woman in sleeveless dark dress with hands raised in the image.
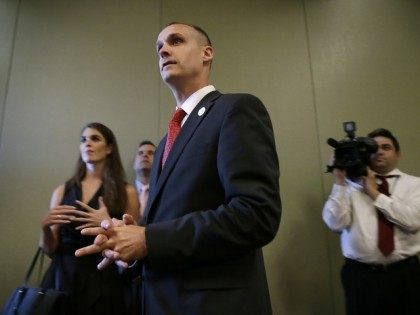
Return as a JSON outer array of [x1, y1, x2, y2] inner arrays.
[[40, 122, 139, 315]]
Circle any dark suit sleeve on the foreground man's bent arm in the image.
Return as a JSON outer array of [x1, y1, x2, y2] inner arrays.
[[146, 94, 281, 269]]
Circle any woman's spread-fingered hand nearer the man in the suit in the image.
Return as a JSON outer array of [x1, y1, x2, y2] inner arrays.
[[72, 197, 111, 230]]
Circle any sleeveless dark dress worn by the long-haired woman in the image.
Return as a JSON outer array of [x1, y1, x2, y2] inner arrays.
[[44, 184, 125, 315]]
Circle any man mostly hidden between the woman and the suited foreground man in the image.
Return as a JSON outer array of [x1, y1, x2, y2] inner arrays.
[[133, 140, 156, 220]]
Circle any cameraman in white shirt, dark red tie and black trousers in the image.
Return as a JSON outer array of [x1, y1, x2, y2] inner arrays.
[[322, 129, 420, 314]]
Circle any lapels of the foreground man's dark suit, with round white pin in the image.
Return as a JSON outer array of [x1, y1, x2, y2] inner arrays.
[[146, 91, 221, 220]]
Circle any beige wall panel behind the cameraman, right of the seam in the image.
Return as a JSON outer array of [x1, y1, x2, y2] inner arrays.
[[307, 0, 420, 314]]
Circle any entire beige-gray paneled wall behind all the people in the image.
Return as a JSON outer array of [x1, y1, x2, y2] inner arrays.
[[0, 0, 420, 314]]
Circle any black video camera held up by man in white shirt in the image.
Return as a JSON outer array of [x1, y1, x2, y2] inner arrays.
[[327, 121, 378, 181]]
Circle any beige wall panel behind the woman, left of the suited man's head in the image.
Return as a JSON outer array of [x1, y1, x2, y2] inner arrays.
[[0, 1, 160, 304]]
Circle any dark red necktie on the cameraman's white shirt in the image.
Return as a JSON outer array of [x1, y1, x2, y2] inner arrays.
[[376, 175, 394, 256]]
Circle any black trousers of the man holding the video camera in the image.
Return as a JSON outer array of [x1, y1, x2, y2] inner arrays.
[[341, 256, 420, 315]]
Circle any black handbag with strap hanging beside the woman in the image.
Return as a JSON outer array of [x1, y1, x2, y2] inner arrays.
[[1, 248, 66, 315]]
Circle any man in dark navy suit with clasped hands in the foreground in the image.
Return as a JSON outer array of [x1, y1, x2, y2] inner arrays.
[[76, 23, 281, 315]]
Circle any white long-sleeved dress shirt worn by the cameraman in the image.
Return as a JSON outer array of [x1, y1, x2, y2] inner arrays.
[[322, 169, 420, 264]]
